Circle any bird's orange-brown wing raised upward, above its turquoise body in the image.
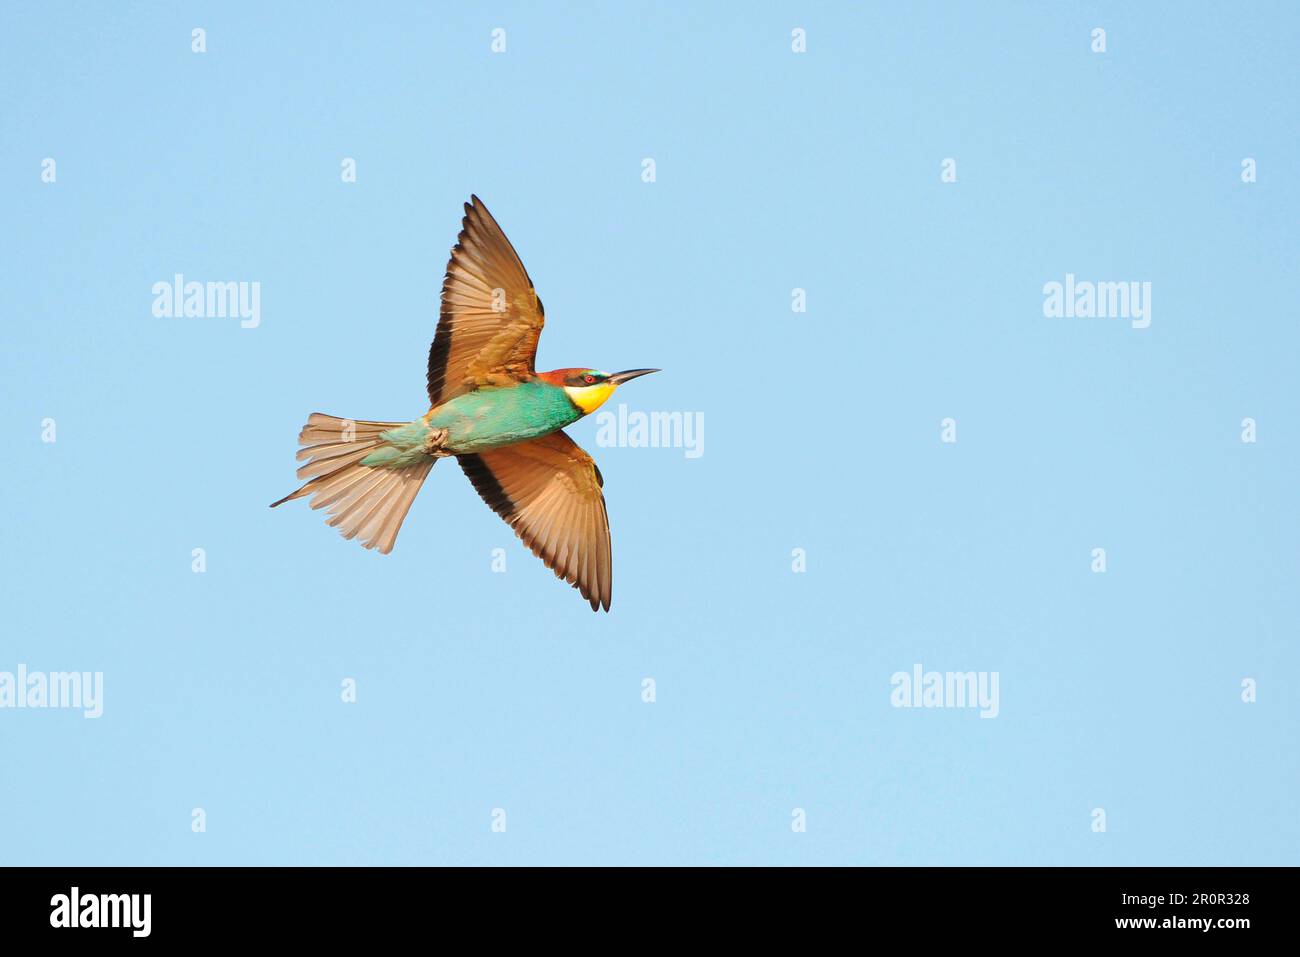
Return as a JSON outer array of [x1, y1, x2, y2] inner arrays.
[[429, 196, 545, 406]]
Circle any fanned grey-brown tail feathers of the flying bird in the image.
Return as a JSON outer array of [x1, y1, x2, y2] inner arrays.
[[270, 412, 436, 555]]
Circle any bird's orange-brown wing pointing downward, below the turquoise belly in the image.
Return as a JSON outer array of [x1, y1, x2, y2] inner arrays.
[[459, 432, 614, 611]]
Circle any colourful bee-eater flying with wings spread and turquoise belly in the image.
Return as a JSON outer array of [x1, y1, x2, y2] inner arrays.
[[272, 196, 659, 611]]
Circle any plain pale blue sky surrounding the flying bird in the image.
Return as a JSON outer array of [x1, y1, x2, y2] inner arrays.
[[0, 3, 1300, 865]]
